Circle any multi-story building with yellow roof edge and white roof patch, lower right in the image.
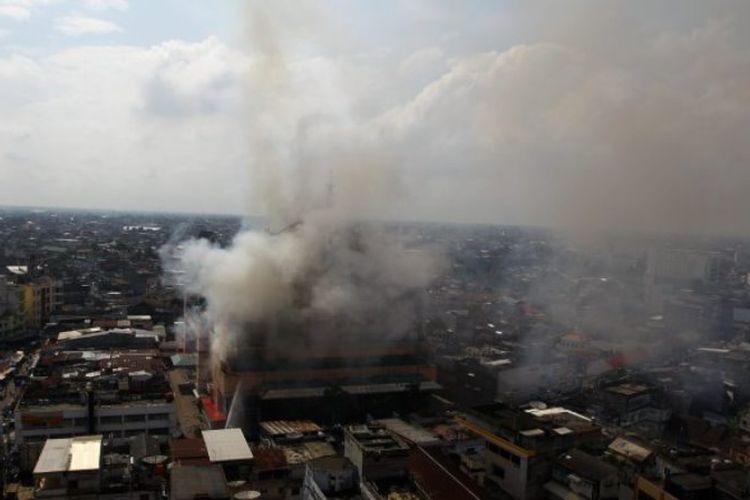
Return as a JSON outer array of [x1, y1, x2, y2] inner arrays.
[[457, 404, 602, 499]]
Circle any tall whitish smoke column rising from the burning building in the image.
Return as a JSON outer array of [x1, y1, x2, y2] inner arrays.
[[167, 2, 438, 359]]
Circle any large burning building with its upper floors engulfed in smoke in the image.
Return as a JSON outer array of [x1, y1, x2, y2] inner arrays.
[[172, 213, 446, 435]]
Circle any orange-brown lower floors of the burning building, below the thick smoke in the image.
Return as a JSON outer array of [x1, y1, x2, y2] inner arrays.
[[209, 319, 440, 436]]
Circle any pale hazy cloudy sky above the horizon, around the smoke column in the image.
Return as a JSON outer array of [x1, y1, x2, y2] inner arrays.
[[0, 0, 750, 233]]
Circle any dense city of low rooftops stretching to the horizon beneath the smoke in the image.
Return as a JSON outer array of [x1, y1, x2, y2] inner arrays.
[[0, 205, 750, 500]]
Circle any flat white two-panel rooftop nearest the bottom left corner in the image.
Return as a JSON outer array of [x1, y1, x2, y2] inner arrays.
[[34, 435, 102, 474]]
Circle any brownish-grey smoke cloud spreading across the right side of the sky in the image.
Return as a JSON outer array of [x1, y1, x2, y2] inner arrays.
[[379, 0, 750, 234]]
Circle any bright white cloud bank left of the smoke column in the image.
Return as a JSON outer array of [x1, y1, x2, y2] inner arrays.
[[0, 39, 247, 211]]
